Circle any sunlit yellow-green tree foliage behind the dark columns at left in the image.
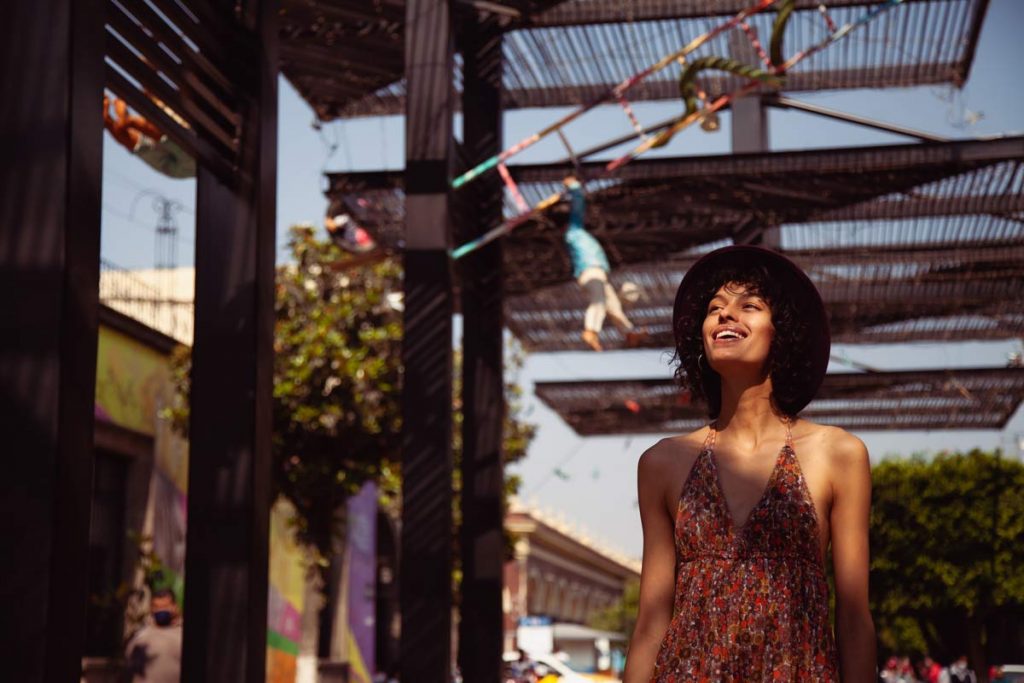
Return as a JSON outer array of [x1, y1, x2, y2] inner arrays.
[[165, 226, 535, 559]]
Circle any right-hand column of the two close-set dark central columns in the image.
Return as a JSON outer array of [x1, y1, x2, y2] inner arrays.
[[459, 12, 505, 683]]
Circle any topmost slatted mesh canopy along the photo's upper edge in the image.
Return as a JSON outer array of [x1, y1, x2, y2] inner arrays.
[[282, 0, 987, 120]]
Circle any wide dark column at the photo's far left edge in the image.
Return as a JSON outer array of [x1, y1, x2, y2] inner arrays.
[[0, 0, 103, 683]]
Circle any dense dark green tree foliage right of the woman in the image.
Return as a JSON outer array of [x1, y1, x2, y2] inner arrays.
[[870, 450, 1024, 670]]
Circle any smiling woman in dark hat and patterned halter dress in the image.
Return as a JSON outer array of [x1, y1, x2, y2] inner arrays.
[[624, 247, 876, 683]]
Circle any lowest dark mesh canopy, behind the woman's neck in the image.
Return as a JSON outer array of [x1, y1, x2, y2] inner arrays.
[[536, 368, 1024, 436]]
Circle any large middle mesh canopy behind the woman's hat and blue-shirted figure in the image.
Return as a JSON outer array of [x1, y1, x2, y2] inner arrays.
[[330, 137, 1024, 351]]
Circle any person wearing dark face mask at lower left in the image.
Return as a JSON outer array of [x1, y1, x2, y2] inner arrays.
[[125, 589, 181, 683]]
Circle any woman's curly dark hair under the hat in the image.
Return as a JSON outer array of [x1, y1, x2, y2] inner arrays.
[[673, 264, 814, 420]]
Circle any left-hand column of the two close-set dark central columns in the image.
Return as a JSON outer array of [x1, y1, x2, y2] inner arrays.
[[399, 0, 453, 683]]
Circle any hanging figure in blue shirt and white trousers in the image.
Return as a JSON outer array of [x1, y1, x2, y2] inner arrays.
[[562, 175, 646, 351]]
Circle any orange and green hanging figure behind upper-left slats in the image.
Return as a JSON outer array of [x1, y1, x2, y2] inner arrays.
[[103, 95, 196, 178]]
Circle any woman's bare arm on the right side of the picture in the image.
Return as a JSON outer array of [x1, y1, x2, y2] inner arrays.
[[830, 432, 876, 683]]
